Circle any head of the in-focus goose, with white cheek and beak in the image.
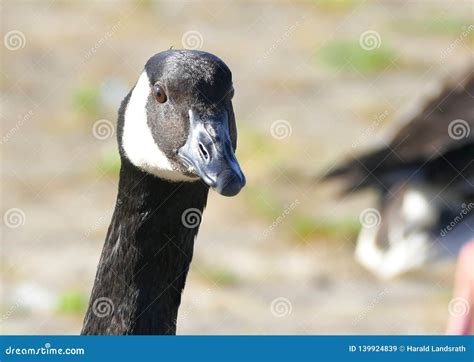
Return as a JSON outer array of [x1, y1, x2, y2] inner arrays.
[[118, 50, 245, 196]]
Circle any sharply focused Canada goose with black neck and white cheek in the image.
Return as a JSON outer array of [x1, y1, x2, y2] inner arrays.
[[82, 50, 245, 335]]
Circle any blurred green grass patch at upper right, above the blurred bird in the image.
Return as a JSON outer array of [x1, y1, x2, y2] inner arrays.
[[316, 40, 397, 73]]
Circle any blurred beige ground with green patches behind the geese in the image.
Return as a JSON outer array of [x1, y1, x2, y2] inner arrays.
[[0, 0, 474, 334]]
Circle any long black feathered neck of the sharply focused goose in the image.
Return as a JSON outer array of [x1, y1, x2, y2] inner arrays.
[[82, 157, 208, 334]]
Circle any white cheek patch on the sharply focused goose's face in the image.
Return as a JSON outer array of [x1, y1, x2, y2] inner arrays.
[[122, 71, 196, 181]]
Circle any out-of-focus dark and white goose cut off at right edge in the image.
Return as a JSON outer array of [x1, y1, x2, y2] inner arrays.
[[324, 66, 474, 277]]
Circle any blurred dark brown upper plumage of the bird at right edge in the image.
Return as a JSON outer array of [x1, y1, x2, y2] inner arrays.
[[325, 69, 474, 192]]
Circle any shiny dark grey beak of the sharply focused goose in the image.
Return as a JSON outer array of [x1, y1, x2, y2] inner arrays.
[[178, 110, 245, 196]]
